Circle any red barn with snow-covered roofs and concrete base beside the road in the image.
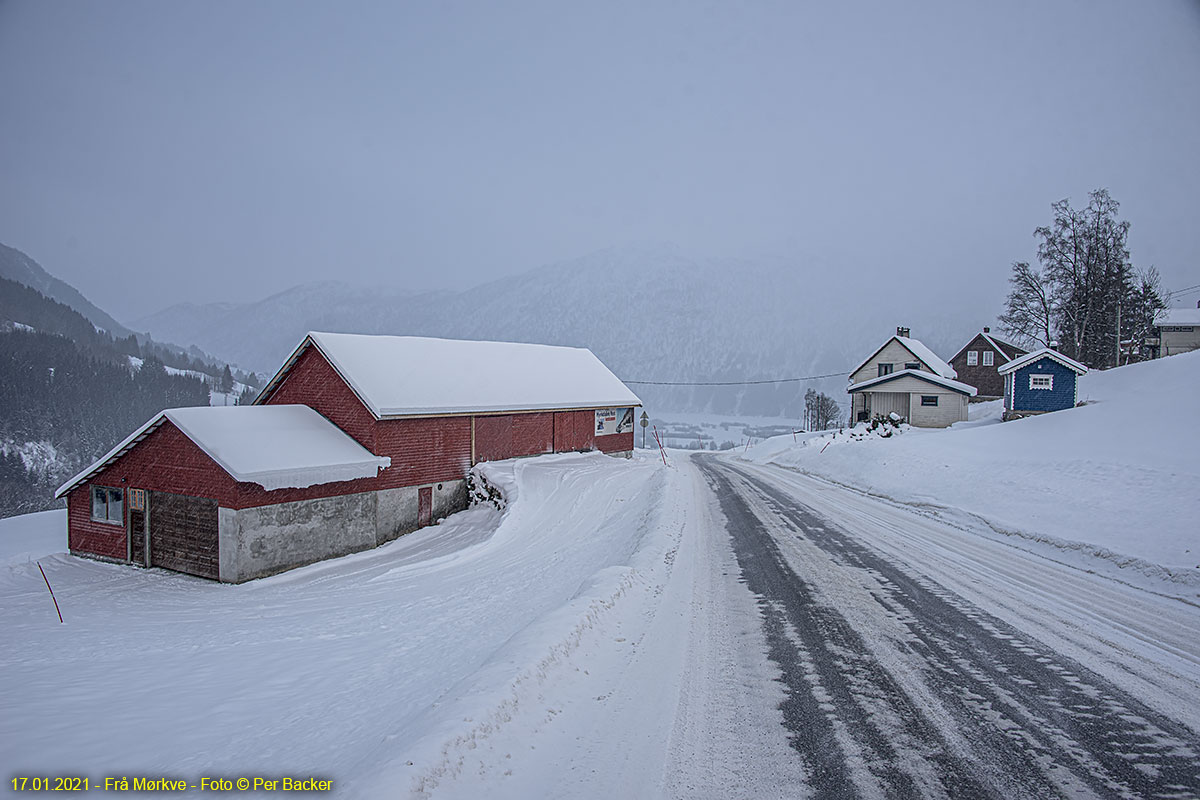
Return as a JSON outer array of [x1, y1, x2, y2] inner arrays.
[[58, 333, 641, 583]]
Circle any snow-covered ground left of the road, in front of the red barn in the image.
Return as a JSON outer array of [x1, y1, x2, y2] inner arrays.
[[0, 453, 799, 798]]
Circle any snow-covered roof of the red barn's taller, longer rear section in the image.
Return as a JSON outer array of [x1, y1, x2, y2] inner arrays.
[[259, 332, 642, 419]]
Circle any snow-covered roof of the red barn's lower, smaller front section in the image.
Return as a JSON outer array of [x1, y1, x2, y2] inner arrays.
[[54, 405, 391, 498]]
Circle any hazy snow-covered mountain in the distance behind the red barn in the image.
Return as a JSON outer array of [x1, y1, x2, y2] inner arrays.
[[131, 246, 990, 416]]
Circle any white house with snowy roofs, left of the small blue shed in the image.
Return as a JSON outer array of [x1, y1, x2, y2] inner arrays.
[[846, 327, 976, 428]]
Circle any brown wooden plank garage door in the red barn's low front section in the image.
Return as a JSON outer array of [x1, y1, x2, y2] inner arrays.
[[149, 492, 221, 579]]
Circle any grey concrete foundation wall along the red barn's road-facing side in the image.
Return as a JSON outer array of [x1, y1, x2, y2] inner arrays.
[[217, 480, 467, 583]]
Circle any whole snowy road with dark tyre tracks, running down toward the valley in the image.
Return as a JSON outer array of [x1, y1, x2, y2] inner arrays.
[[695, 457, 1200, 798]]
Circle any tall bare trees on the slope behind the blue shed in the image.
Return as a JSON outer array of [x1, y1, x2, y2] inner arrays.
[[1000, 190, 1166, 368]]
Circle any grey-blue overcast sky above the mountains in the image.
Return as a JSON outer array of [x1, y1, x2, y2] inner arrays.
[[0, 0, 1200, 320]]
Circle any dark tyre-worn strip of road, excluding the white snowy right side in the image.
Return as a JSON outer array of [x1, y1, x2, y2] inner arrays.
[[697, 458, 1200, 798]]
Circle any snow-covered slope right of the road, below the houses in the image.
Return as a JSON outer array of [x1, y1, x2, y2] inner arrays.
[[742, 351, 1200, 596]]
